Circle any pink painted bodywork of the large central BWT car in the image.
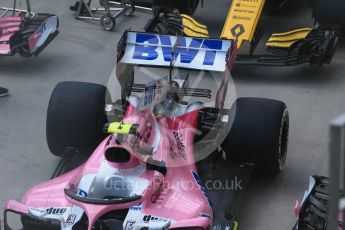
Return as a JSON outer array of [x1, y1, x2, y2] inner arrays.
[[6, 104, 213, 230]]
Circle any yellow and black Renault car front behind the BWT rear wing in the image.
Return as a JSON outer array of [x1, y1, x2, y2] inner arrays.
[[145, 0, 345, 66]]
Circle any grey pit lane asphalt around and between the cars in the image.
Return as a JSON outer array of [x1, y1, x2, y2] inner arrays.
[[0, 0, 345, 230]]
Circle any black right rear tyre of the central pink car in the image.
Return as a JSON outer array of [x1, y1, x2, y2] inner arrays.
[[222, 98, 289, 176]]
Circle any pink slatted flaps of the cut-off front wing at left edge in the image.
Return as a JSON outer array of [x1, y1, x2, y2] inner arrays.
[[0, 16, 22, 55]]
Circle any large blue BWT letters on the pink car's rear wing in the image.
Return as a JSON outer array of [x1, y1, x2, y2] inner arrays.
[[133, 34, 223, 66]]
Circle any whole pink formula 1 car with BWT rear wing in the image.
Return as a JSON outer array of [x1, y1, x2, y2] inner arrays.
[[4, 32, 289, 230]]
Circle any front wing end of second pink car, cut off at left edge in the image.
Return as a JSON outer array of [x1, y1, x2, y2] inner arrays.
[[0, 0, 59, 57]]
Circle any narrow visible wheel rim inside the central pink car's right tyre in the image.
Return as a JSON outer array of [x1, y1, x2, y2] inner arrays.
[[279, 110, 289, 170]]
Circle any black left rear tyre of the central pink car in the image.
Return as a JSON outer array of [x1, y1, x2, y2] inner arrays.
[[46, 82, 107, 156]]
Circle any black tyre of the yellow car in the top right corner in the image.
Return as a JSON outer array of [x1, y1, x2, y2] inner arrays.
[[311, 0, 345, 35]]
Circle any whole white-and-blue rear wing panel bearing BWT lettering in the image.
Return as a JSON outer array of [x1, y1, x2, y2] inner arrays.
[[119, 32, 234, 72]]
